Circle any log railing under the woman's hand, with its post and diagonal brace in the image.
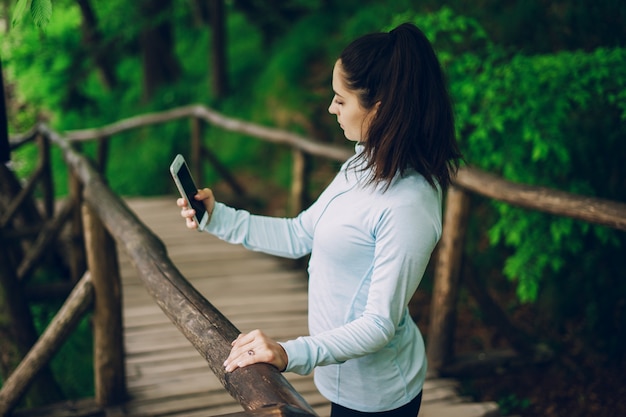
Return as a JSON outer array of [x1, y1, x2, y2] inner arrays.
[[0, 115, 316, 416]]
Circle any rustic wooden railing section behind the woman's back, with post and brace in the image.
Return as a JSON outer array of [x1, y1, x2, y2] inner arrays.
[[427, 167, 626, 376]]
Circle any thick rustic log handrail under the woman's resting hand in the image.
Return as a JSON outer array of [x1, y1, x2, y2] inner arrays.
[[40, 125, 316, 416]]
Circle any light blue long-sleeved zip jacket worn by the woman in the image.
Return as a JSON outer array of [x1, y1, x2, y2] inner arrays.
[[205, 146, 442, 412]]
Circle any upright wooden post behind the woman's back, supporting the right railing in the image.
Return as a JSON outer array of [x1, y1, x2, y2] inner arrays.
[[426, 185, 469, 376]]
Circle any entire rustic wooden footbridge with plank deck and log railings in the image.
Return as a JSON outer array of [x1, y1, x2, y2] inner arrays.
[[0, 106, 626, 417]]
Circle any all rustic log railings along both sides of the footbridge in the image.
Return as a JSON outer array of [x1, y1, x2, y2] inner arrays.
[[0, 105, 626, 415]]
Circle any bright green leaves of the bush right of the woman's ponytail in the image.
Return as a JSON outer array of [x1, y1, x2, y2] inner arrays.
[[391, 8, 626, 302]]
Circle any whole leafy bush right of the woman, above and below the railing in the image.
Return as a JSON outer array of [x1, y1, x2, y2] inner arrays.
[[402, 8, 626, 356]]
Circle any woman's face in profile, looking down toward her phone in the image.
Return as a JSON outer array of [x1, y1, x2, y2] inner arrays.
[[328, 61, 375, 142]]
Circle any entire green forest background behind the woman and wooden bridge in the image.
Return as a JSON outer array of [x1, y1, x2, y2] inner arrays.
[[0, 0, 626, 416]]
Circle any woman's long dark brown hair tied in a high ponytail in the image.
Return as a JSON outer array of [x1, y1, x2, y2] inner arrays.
[[339, 23, 462, 188]]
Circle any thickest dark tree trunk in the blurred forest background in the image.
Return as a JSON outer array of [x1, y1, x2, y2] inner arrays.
[[140, 0, 180, 100]]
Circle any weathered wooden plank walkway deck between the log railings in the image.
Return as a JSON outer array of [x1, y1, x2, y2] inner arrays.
[[119, 196, 499, 417]]
